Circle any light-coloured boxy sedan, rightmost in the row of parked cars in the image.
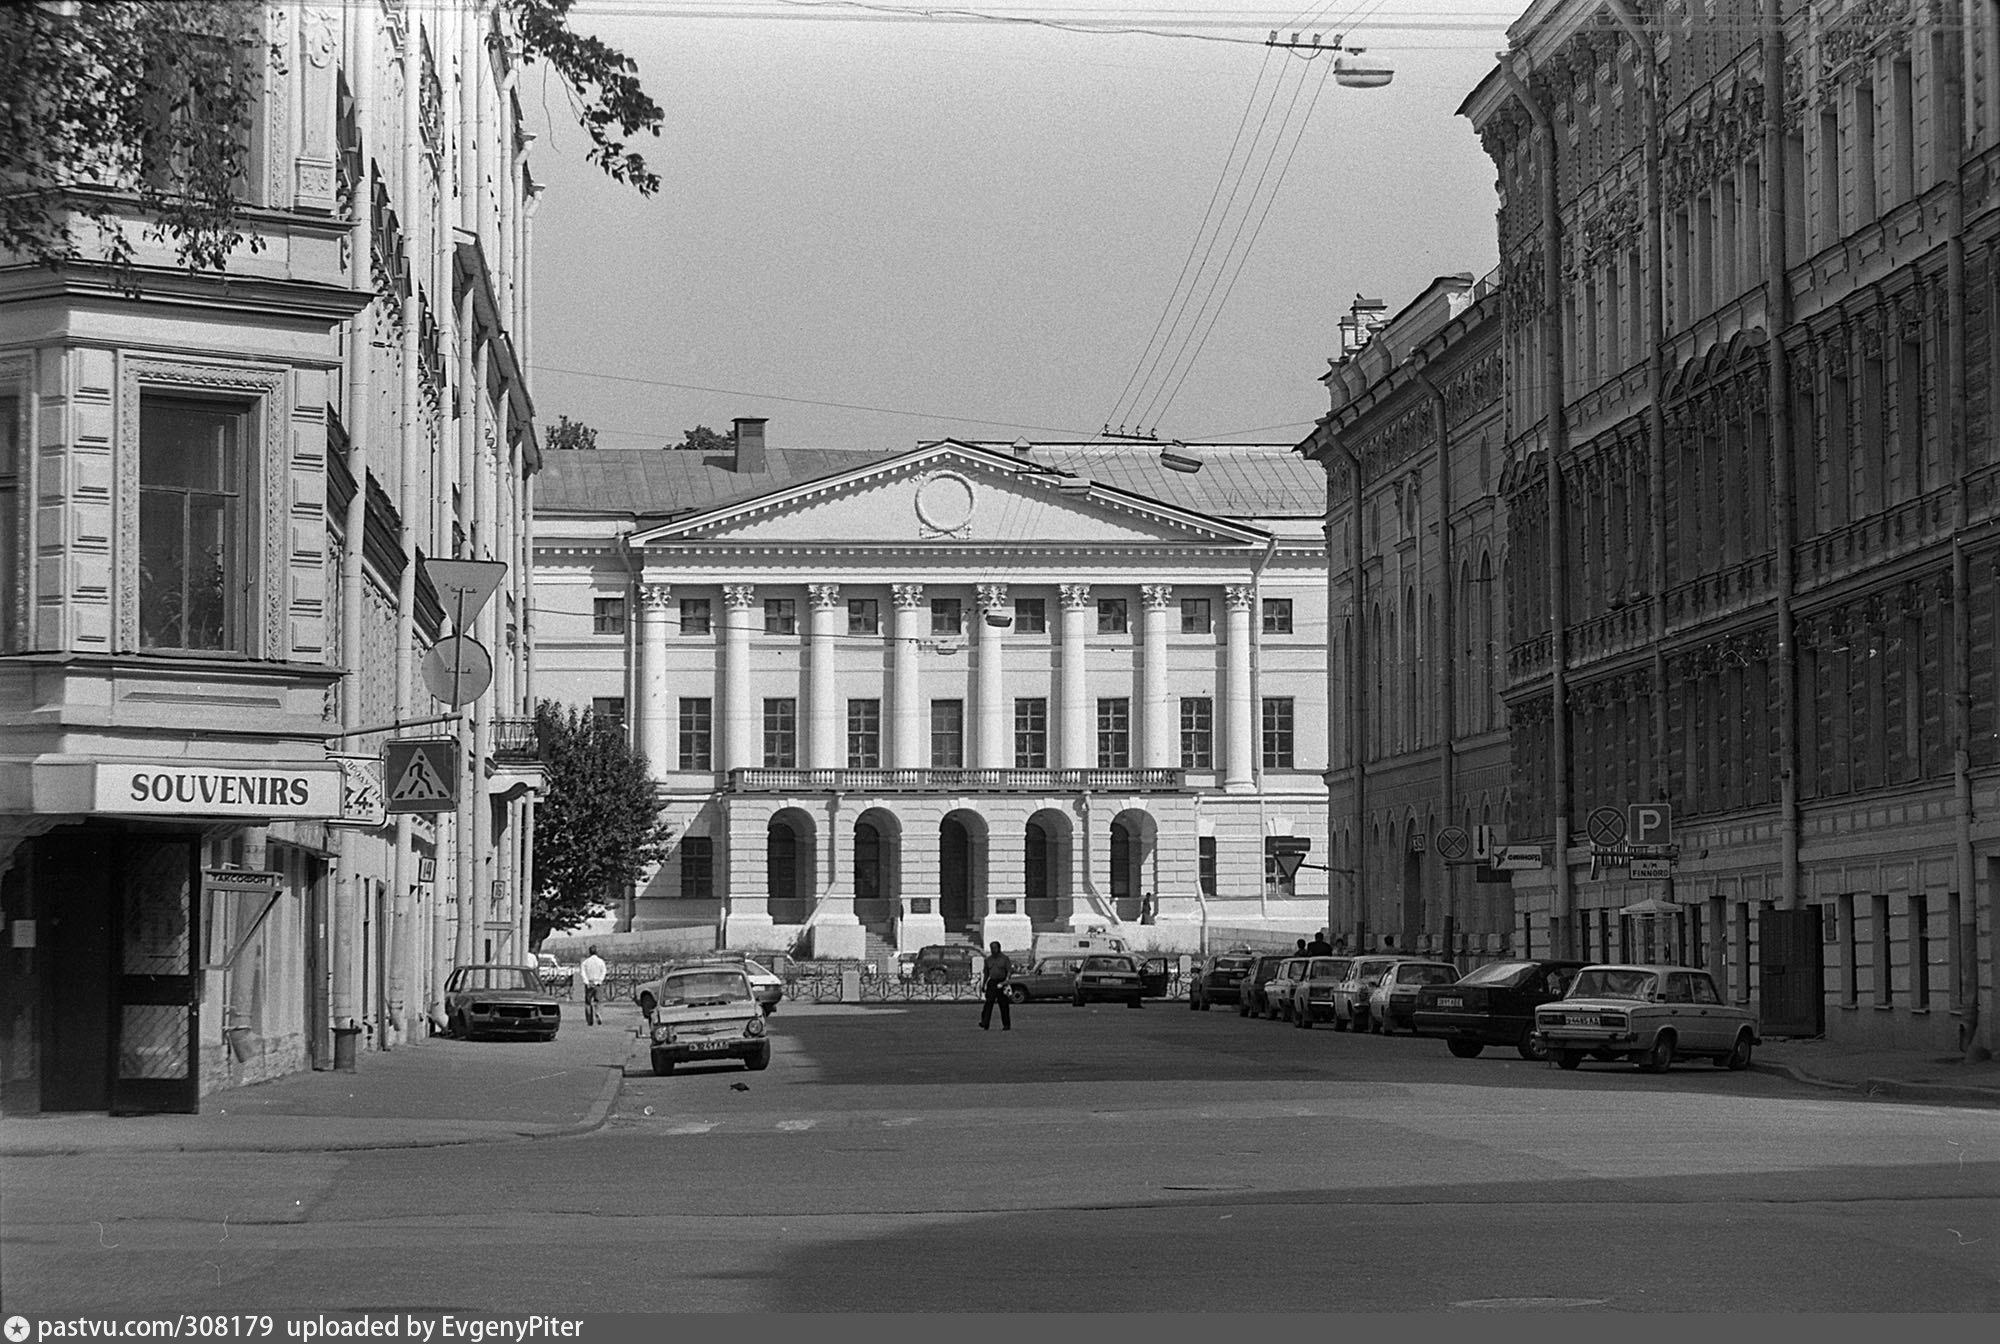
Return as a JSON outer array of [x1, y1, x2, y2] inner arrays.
[[1534, 966, 1762, 1074]]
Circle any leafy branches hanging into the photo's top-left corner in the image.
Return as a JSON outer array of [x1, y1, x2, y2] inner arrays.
[[0, 0, 662, 292]]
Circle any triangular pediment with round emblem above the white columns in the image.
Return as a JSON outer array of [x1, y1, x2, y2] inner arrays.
[[632, 440, 1266, 546]]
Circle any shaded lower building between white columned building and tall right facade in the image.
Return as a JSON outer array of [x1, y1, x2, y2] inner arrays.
[[1300, 276, 1514, 960]]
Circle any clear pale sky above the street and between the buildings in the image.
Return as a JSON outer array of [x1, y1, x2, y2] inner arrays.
[[520, 0, 1526, 450]]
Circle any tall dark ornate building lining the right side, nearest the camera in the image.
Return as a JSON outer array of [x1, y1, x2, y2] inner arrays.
[[1462, 0, 2000, 1048]]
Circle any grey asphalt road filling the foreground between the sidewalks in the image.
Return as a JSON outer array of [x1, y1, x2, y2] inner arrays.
[[0, 1004, 2000, 1312]]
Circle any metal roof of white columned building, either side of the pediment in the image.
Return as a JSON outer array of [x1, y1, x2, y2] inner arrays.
[[534, 440, 1326, 518]]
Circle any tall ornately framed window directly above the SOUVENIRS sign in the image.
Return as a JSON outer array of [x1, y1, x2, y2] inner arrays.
[[138, 396, 252, 652]]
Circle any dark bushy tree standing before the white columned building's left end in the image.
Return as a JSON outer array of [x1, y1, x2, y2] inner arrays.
[[528, 700, 670, 946]]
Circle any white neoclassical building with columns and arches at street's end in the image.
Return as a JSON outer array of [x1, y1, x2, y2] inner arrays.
[[536, 420, 1328, 958]]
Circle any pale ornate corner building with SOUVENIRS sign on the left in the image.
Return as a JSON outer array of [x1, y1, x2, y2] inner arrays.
[[0, 2, 540, 1116]]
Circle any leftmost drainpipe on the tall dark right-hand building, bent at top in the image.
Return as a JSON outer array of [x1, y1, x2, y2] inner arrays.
[[1500, 58, 1576, 956]]
